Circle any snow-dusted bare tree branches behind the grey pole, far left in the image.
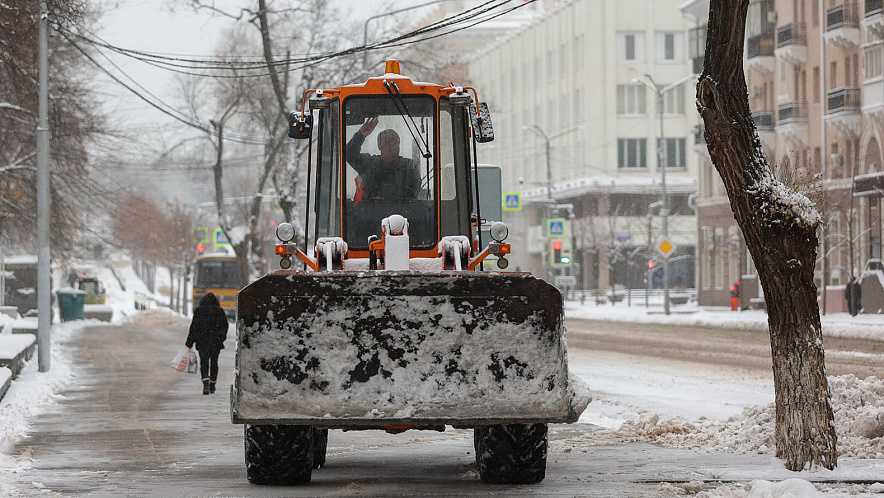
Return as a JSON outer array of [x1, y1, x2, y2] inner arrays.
[[0, 0, 107, 258]]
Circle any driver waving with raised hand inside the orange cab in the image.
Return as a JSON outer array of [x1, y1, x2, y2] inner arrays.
[[346, 117, 421, 202]]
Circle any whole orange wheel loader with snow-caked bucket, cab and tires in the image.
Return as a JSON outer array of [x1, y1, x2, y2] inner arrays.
[[231, 61, 589, 485]]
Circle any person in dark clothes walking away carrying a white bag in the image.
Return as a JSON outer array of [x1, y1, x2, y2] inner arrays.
[[184, 292, 228, 394]]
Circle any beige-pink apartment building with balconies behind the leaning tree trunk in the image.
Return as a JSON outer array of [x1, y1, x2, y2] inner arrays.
[[680, 0, 884, 313]]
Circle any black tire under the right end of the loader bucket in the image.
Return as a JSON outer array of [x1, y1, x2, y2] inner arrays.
[[474, 424, 548, 484]]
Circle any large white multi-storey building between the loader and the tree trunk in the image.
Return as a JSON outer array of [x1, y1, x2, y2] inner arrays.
[[468, 0, 698, 289]]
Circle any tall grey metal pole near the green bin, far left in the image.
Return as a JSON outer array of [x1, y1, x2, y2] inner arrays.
[[37, 0, 52, 372]]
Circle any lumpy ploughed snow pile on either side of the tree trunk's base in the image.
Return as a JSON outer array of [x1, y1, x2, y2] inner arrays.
[[614, 374, 884, 460]]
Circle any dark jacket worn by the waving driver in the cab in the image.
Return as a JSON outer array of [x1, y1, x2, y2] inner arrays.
[[347, 131, 421, 200]]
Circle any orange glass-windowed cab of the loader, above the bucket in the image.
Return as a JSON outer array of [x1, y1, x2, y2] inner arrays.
[[277, 61, 509, 270]]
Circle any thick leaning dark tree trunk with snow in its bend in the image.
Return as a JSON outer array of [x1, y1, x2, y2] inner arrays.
[[697, 0, 837, 471]]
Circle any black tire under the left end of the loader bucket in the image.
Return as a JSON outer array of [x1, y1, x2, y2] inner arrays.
[[245, 425, 313, 486]]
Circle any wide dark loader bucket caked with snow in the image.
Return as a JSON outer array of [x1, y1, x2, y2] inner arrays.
[[231, 271, 588, 428]]
